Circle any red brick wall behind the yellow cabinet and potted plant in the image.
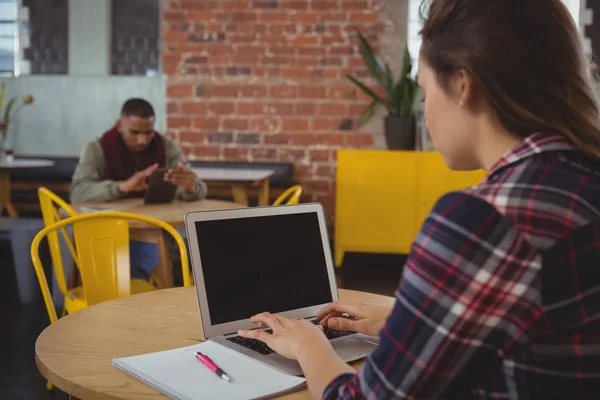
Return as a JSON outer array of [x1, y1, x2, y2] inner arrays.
[[162, 0, 389, 222]]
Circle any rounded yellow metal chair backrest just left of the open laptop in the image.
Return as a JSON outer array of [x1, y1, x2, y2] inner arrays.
[[31, 212, 191, 322]]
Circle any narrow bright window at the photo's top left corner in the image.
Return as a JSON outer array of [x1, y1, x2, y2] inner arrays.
[[0, 0, 19, 75]]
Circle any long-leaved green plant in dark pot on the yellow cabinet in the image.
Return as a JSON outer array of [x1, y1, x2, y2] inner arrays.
[[348, 32, 419, 150]]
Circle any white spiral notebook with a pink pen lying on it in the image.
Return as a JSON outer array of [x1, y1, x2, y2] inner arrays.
[[112, 341, 305, 400]]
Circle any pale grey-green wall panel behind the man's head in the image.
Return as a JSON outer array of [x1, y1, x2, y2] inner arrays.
[[0, 75, 166, 155]]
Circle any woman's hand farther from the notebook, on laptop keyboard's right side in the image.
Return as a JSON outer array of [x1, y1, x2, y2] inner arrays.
[[317, 301, 392, 336]]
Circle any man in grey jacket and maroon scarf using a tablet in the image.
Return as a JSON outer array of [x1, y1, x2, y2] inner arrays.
[[69, 99, 206, 280]]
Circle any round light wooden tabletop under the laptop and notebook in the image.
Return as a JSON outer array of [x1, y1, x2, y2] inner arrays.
[[35, 287, 394, 400]]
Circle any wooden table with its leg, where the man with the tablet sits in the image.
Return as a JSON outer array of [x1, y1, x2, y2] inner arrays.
[[72, 199, 244, 288]]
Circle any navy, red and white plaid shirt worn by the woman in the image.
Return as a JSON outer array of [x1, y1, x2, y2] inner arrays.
[[324, 133, 600, 399]]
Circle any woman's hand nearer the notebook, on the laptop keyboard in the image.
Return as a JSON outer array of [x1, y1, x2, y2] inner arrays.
[[238, 313, 333, 360]]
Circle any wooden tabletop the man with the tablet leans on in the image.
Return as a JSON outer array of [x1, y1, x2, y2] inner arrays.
[[73, 199, 243, 228]]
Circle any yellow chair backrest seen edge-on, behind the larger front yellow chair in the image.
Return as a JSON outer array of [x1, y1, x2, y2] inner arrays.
[[38, 187, 79, 295]]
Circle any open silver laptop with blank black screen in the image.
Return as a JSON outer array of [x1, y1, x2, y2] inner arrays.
[[185, 204, 378, 376]]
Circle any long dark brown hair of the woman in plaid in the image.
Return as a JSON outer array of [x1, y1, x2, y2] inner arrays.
[[421, 0, 600, 159]]
